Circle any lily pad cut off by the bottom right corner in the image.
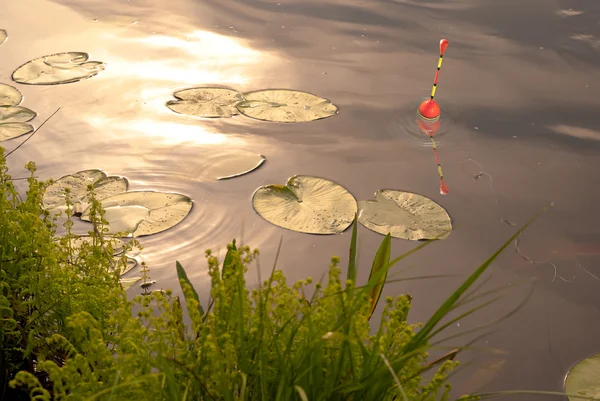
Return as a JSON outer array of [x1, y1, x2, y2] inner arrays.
[[565, 354, 600, 401]]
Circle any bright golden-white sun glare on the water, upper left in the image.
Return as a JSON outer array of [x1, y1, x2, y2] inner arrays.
[[84, 30, 277, 147]]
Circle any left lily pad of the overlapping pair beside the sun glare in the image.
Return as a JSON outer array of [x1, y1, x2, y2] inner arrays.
[[167, 87, 243, 118]]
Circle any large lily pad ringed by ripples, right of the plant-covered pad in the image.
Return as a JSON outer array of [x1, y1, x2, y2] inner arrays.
[[81, 191, 193, 237]]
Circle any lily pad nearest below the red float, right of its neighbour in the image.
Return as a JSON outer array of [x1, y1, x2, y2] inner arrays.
[[358, 189, 452, 241]]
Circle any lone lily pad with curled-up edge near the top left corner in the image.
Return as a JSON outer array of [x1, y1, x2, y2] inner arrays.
[[12, 52, 104, 85]]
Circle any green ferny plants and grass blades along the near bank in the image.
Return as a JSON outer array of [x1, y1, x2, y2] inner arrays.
[[0, 147, 589, 401]]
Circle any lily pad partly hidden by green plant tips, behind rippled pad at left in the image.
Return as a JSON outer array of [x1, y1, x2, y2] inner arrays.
[[42, 170, 129, 214]]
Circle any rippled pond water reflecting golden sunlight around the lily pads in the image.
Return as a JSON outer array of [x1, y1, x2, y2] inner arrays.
[[0, 0, 600, 399]]
